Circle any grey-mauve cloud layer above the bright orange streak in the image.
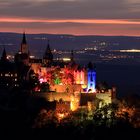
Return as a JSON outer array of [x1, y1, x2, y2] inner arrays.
[[0, 0, 140, 19]]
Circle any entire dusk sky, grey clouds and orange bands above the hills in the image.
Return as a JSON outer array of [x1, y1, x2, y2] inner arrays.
[[0, 0, 140, 36]]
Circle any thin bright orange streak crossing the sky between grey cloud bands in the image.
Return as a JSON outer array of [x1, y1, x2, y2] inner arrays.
[[0, 18, 140, 25]]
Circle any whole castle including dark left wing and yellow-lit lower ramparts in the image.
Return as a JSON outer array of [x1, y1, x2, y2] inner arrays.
[[0, 33, 116, 110]]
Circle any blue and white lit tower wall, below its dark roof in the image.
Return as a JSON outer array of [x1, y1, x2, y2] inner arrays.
[[87, 70, 96, 92]]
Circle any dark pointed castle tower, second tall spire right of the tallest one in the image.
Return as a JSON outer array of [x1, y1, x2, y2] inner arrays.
[[43, 41, 53, 66]]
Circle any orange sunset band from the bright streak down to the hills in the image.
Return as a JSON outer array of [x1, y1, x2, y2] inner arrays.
[[0, 17, 140, 36]]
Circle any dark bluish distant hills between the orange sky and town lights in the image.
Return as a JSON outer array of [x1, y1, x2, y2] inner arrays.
[[0, 32, 140, 56]]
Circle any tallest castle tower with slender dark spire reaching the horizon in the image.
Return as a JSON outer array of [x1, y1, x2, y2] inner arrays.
[[20, 32, 28, 54]]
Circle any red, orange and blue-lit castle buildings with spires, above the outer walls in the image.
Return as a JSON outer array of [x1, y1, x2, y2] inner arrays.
[[12, 33, 96, 93]]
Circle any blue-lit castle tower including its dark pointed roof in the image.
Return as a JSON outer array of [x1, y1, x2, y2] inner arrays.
[[87, 62, 96, 93]]
